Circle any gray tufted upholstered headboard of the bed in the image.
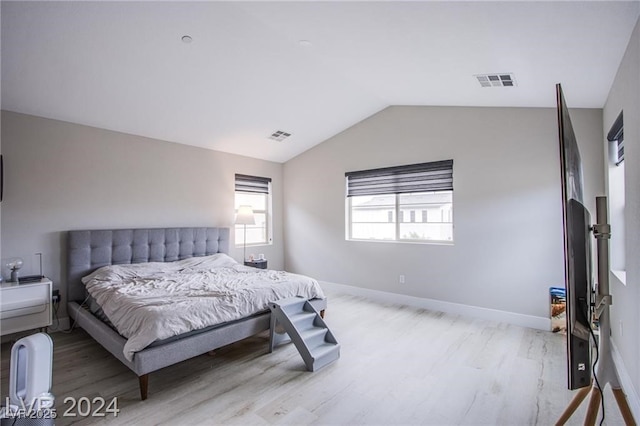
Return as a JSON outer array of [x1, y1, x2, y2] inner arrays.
[[67, 228, 229, 302]]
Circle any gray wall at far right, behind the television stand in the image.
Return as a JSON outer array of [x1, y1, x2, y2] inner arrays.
[[603, 16, 640, 408]]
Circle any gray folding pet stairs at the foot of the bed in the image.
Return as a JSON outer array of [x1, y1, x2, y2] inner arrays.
[[269, 297, 340, 371]]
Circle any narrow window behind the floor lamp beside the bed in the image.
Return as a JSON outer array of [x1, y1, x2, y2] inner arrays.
[[235, 174, 272, 247]]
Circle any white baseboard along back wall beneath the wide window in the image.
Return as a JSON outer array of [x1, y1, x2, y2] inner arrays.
[[320, 281, 551, 331]]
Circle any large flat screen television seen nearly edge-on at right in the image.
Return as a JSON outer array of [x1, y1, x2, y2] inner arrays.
[[556, 84, 593, 389]]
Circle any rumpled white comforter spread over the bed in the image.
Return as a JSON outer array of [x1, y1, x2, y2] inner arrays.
[[82, 253, 324, 360]]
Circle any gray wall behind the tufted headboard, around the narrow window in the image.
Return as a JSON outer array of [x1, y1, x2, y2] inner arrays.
[[1, 111, 283, 316]]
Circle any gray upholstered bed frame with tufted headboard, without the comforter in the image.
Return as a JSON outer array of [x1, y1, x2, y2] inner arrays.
[[67, 228, 327, 400]]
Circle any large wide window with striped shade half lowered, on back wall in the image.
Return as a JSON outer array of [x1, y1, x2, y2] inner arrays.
[[345, 160, 453, 242]]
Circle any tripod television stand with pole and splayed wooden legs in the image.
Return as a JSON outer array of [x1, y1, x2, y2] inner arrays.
[[556, 197, 636, 425]]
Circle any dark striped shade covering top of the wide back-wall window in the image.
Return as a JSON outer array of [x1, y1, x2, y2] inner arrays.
[[345, 160, 453, 197]]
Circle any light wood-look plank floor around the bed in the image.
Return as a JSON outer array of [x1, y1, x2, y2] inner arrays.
[[2, 294, 623, 425]]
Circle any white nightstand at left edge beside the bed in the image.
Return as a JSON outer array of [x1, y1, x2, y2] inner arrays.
[[0, 278, 52, 336]]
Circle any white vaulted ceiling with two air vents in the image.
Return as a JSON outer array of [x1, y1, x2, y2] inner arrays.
[[1, 1, 640, 162]]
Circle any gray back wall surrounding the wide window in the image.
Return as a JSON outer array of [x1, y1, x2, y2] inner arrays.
[[284, 105, 604, 317]]
